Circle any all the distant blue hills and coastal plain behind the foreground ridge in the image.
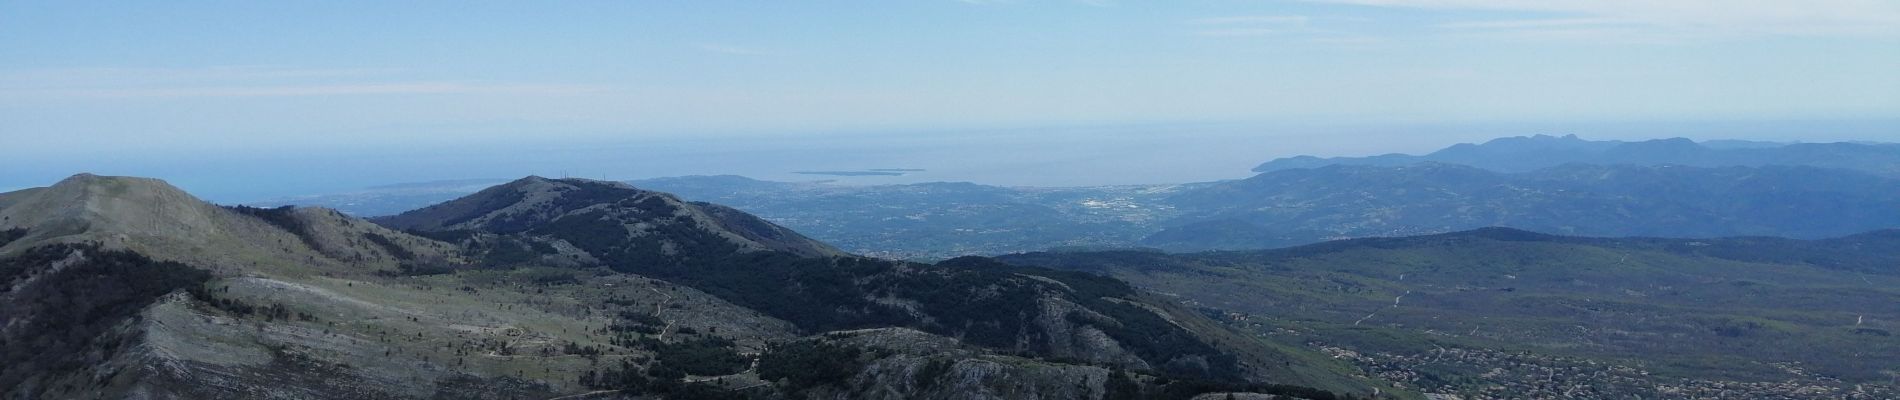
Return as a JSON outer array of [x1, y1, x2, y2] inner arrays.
[[260, 136, 1900, 260]]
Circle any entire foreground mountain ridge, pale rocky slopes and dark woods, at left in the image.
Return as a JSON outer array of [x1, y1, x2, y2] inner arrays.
[[0, 176, 1416, 398]]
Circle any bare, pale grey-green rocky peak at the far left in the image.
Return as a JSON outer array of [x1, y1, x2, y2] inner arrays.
[[0, 174, 456, 271]]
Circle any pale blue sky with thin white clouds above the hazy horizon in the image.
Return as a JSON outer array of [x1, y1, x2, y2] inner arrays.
[[0, 0, 1900, 198]]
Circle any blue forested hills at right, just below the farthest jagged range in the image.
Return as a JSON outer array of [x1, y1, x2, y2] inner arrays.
[[1144, 163, 1900, 250]]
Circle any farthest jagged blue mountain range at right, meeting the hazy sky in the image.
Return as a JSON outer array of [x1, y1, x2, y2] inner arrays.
[[1254, 135, 1900, 176]]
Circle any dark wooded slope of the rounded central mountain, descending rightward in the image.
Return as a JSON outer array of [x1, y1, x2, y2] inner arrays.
[[378, 176, 1390, 394]]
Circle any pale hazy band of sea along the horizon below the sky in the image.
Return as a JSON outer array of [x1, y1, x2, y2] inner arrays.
[[0, 119, 1894, 203]]
